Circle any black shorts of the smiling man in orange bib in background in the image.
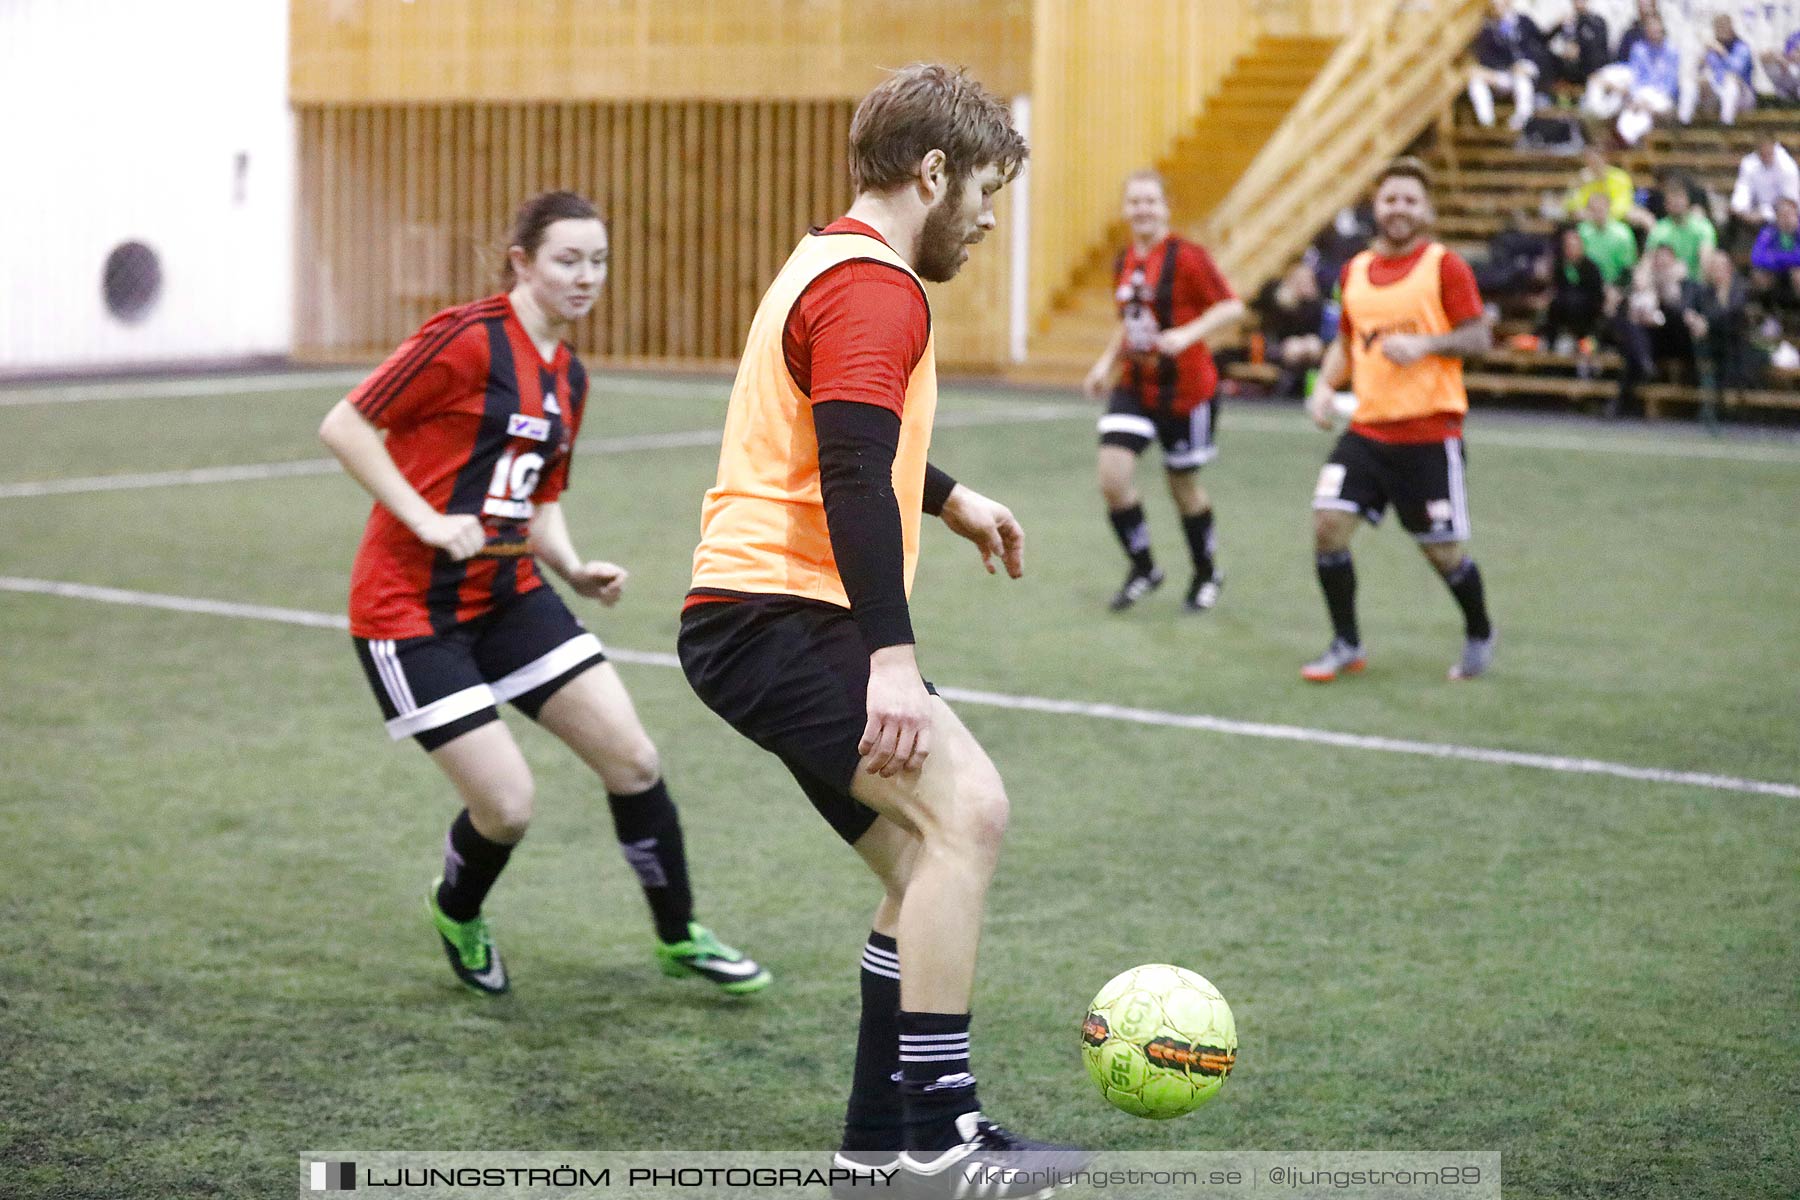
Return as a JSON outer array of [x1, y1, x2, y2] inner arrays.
[[1312, 432, 1469, 542]]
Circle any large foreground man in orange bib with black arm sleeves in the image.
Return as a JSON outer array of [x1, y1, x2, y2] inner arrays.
[[679, 65, 1085, 1196]]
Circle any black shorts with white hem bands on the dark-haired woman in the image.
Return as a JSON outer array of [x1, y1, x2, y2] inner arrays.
[[351, 585, 607, 750]]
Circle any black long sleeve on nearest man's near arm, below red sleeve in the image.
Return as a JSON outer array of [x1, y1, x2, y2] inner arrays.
[[812, 399, 914, 653]]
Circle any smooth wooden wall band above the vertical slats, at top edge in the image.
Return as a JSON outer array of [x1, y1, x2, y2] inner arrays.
[[290, 0, 1031, 104]]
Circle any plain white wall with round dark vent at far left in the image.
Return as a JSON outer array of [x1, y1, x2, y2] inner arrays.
[[0, 0, 293, 371]]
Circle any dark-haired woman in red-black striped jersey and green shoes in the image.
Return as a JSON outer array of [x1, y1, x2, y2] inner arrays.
[[319, 193, 769, 993]]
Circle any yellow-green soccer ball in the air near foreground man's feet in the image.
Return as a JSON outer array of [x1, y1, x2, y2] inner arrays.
[[1082, 963, 1237, 1121]]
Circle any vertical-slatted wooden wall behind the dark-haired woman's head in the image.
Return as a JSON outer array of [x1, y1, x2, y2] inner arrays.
[[295, 101, 1010, 369]]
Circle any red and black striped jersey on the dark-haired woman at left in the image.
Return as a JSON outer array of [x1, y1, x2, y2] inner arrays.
[[349, 295, 587, 639]]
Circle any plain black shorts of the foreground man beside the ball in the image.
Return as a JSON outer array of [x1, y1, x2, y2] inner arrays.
[[675, 596, 936, 844]]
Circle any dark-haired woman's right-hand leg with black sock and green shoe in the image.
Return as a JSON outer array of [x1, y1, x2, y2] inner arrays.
[[538, 662, 770, 995]]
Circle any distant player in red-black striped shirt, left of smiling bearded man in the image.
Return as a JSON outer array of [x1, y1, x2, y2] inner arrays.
[[1085, 171, 1244, 612]]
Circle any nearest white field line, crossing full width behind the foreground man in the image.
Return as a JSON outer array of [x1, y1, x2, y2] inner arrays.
[[0, 576, 1800, 801]]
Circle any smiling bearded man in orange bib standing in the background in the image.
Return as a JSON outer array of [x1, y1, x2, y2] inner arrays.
[[1300, 158, 1494, 684]]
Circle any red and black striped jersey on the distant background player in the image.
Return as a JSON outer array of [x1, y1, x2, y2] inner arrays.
[[1112, 234, 1235, 417]]
